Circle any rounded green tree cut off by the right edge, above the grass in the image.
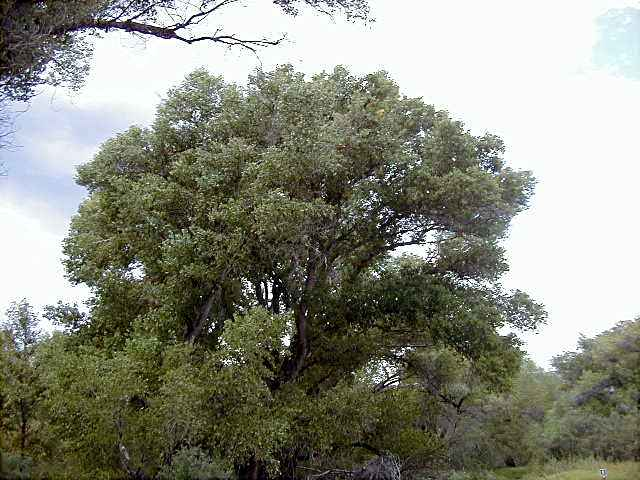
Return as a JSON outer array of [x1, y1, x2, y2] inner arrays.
[[547, 319, 640, 460]]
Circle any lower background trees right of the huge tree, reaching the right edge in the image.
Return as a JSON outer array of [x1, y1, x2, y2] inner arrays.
[[444, 320, 640, 472]]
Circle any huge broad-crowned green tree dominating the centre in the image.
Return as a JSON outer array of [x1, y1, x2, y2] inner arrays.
[[50, 67, 544, 478]]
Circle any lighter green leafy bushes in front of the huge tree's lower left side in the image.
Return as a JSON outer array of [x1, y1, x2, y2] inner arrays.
[[37, 311, 296, 476]]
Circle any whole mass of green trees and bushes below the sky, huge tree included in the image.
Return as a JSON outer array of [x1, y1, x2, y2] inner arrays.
[[0, 66, 640, 480]]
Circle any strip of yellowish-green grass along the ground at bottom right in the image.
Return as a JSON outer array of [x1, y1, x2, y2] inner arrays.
[[494, 459, 640, 480]]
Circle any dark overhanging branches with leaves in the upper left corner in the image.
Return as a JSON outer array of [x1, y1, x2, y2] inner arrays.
[[0, 0, 370, 152]]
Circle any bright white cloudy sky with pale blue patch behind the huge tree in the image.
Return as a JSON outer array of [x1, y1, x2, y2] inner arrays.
[[0, 0, 640, 367]]
